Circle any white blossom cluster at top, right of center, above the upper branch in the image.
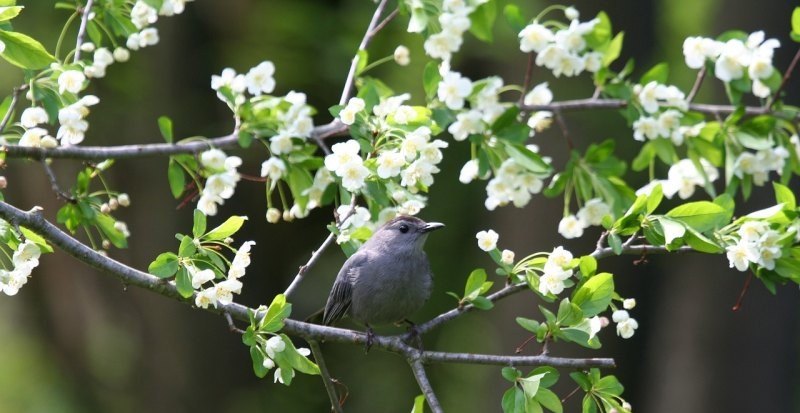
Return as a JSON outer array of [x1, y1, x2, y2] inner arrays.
[[519, 9, 603, 77]]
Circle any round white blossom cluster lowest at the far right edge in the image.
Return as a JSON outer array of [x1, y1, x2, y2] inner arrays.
[[726, 220, 782, 271]]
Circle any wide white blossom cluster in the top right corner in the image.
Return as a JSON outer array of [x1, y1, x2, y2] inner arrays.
[[683, 31, 781, 98]]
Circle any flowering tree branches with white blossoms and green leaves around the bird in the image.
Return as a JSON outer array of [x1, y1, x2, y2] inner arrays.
[[0, 0, 800, 412]]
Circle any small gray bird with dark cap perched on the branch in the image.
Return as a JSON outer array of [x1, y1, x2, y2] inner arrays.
[[323, 216, 444, 350]]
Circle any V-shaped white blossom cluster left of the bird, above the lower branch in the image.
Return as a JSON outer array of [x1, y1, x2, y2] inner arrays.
[[194, 241, 255, 308]]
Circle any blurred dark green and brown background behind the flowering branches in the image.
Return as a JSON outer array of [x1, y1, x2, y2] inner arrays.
[[0, 0, 800, 413]]
